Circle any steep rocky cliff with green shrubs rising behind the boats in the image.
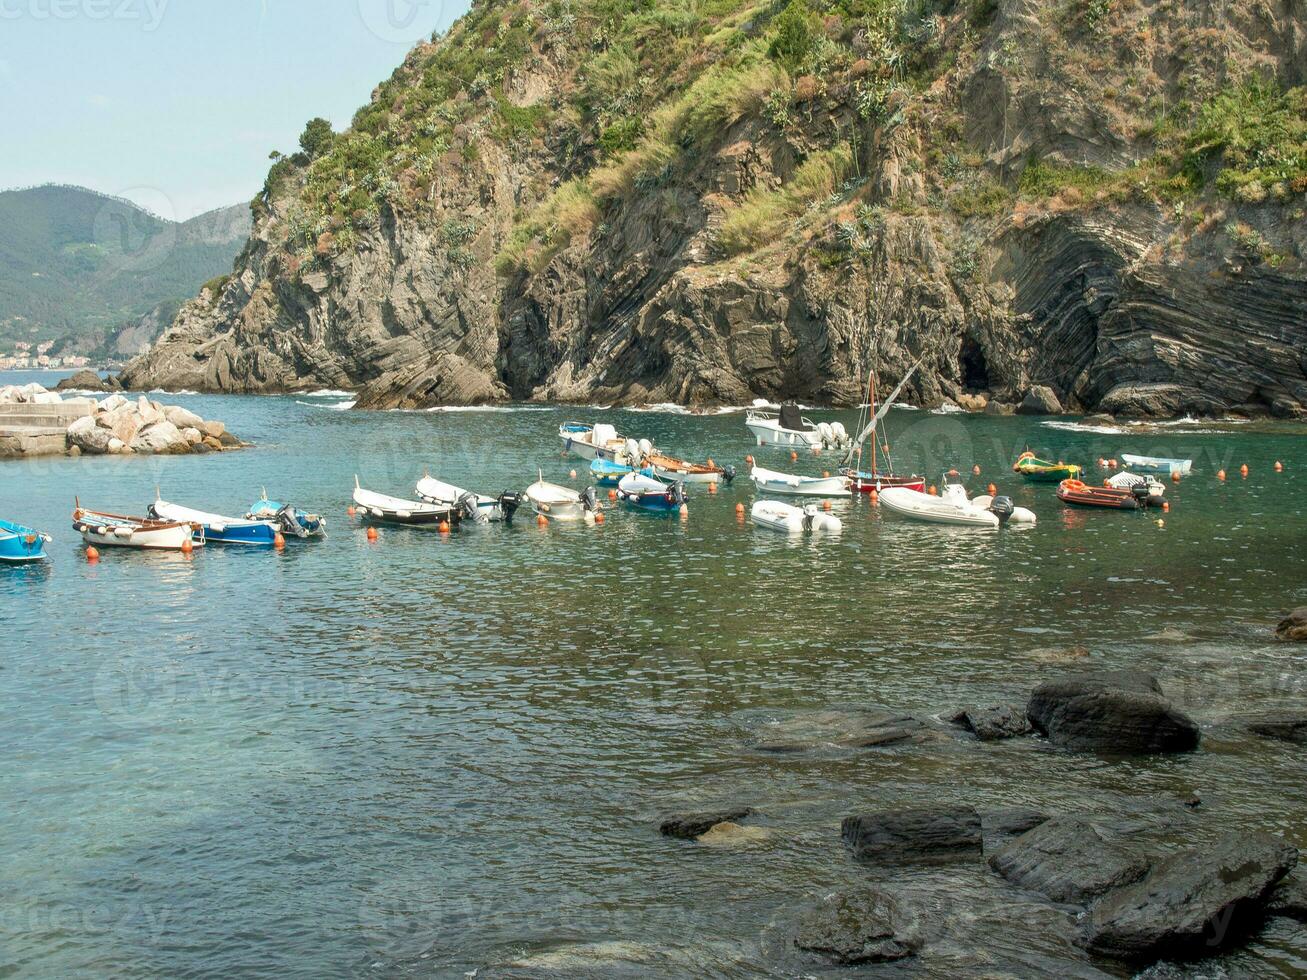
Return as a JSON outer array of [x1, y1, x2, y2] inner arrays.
[[117, 0, 1307, 416]]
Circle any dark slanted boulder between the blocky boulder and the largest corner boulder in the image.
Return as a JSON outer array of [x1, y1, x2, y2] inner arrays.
[[989, 817, 1149, 902]]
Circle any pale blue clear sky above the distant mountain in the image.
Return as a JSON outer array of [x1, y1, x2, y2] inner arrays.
[[0, 0, 468, 220]]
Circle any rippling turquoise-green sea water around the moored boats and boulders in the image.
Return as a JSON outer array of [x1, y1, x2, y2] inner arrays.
[[0, 375, 1307, 977]]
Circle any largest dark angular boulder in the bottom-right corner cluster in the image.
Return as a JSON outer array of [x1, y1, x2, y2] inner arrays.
[[1078, 831, 1298, 960]]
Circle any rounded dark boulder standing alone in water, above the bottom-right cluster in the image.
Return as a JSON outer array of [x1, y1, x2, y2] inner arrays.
[[1026, 670, 1199, 755]]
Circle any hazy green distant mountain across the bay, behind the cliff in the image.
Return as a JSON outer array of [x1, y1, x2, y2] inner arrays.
[[0, 184, 251, 354]]
